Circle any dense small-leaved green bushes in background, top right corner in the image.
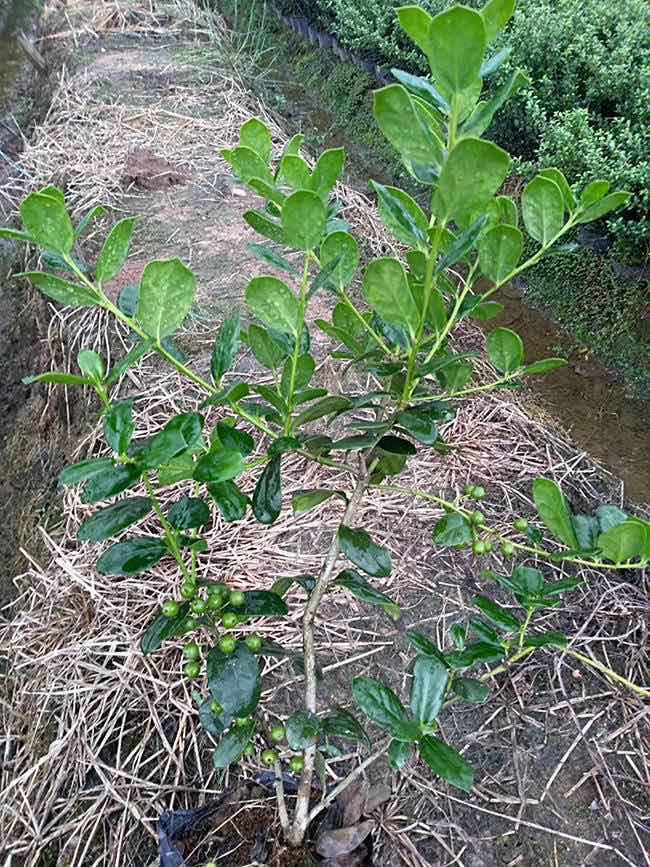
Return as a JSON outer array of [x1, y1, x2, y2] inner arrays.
[[280, 0, 650, 262]]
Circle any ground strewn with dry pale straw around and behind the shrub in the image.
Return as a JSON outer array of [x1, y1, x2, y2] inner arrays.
[[0, 0, 650, 867]]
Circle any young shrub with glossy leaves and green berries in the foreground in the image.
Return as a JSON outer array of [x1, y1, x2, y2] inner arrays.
[[1, 0, 650, 845]]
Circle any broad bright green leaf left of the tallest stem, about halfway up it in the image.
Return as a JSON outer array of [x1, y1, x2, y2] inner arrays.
[[363, 257, 419, 337]]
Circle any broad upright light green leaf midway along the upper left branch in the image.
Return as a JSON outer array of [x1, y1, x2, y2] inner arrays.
[[136, 259, 196, 341]]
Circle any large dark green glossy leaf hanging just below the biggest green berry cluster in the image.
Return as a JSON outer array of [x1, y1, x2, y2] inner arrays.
[[207, 641, 261, 719]]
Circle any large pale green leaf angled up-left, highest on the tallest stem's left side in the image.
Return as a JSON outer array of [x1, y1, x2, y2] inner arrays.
[[373, 84, 443, 171]]
